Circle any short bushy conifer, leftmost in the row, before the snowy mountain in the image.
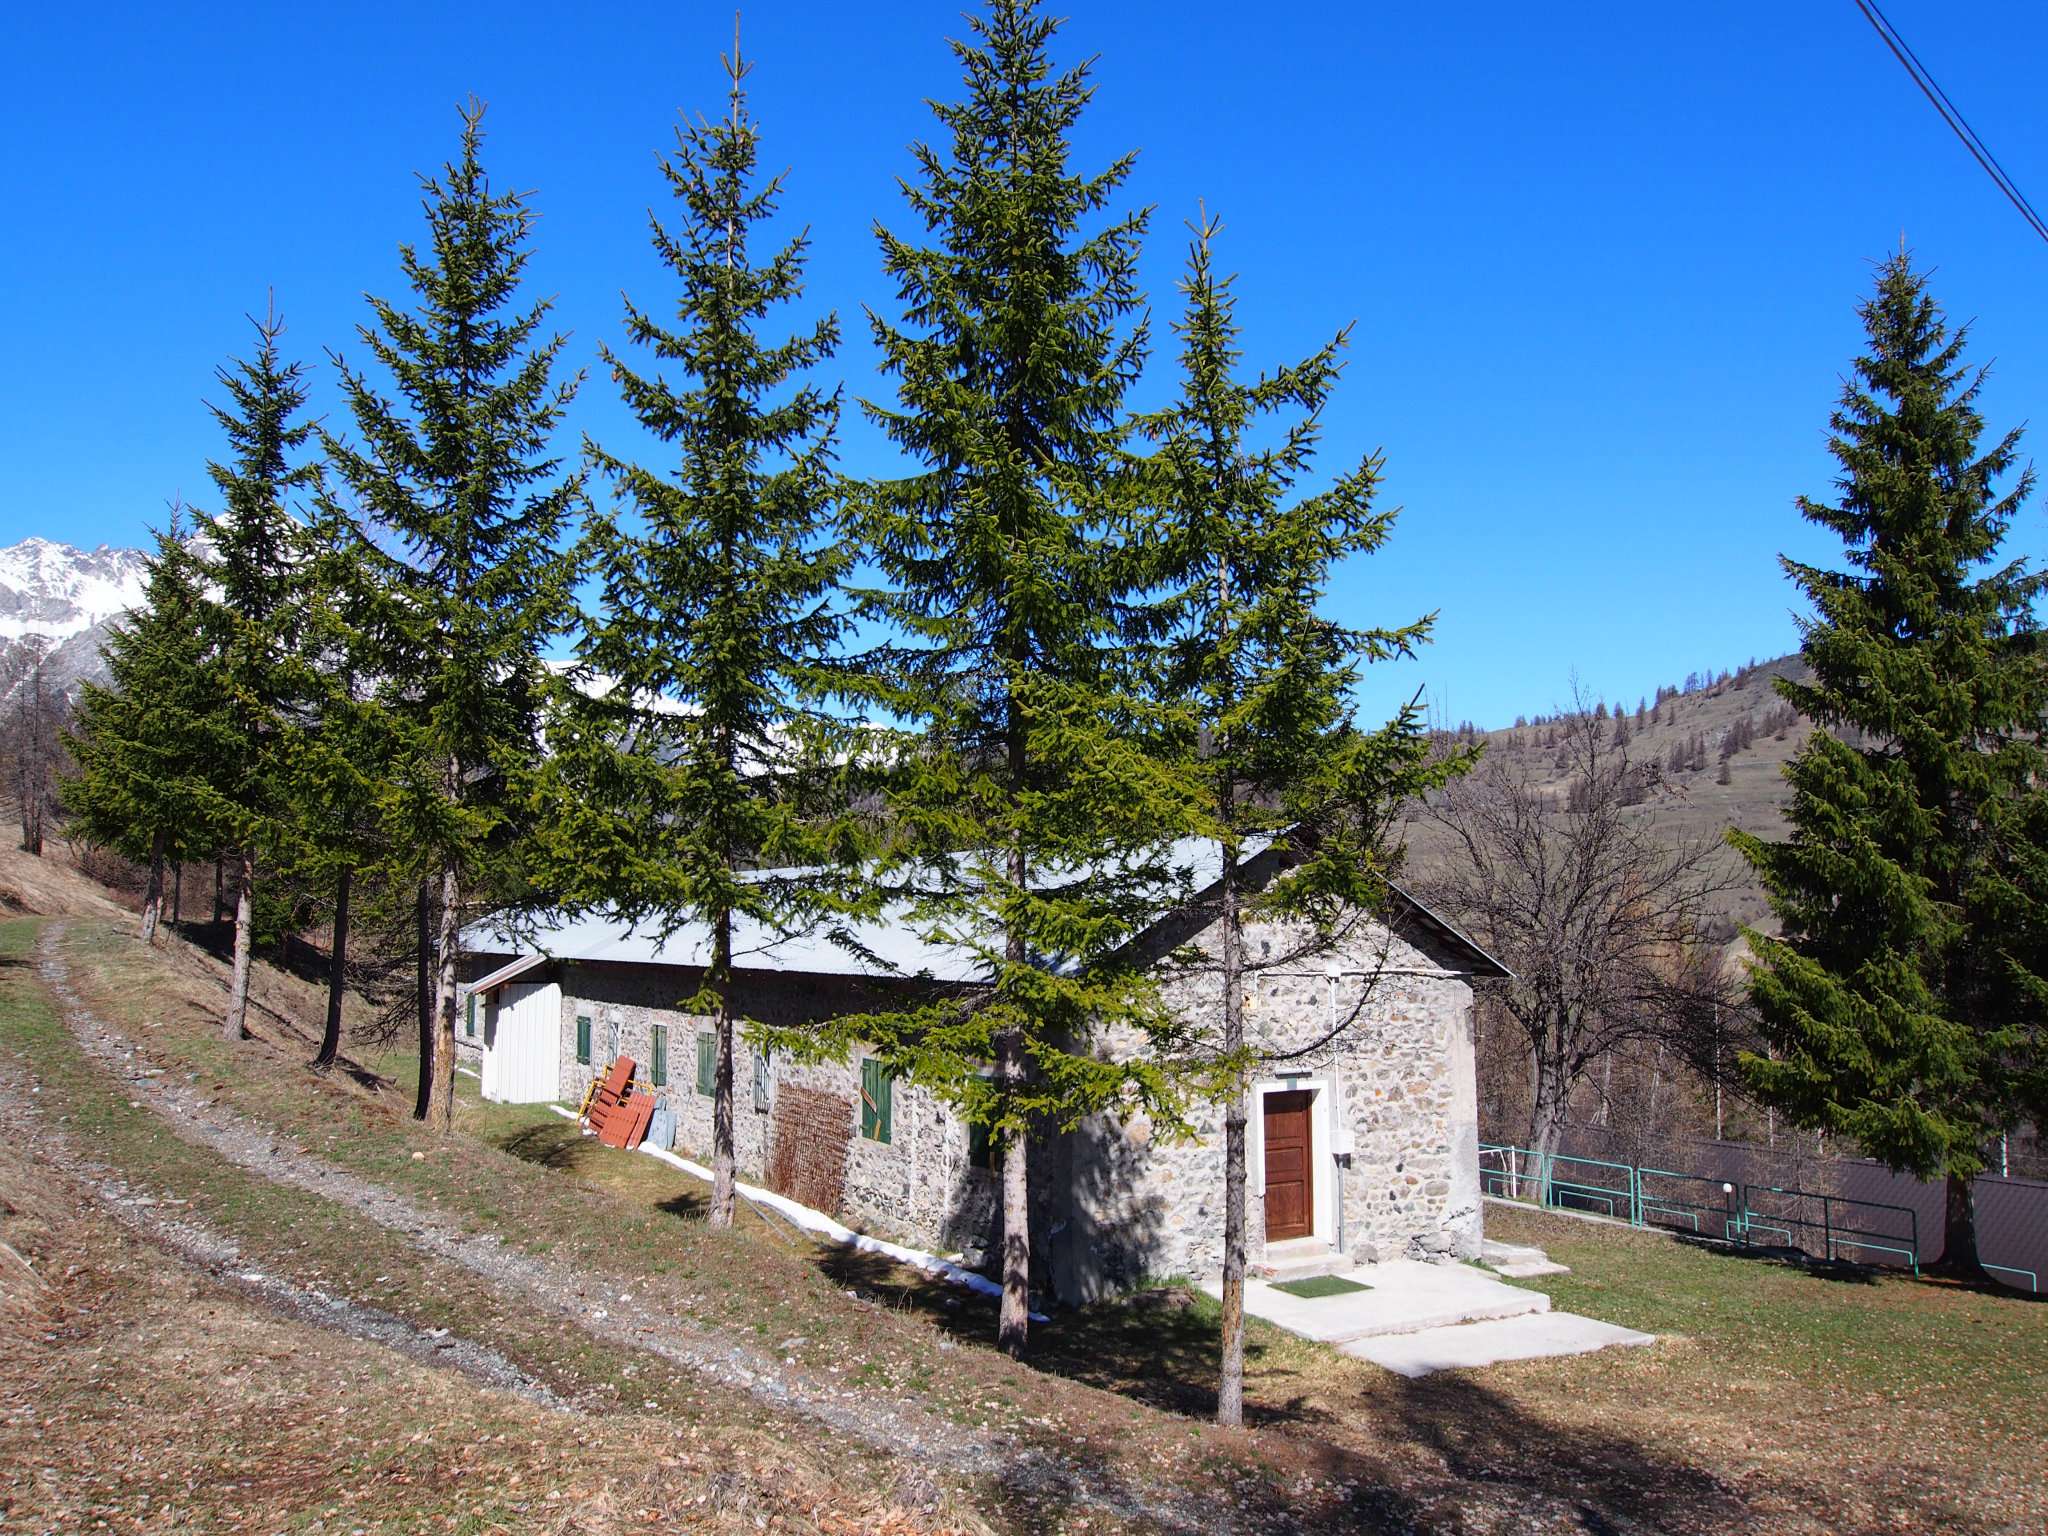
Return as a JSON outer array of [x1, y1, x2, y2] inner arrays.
[[63, 506, 233, 944]]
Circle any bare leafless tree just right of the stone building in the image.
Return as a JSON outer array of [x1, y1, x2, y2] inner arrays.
[[1417, 705, 1737, 1167]]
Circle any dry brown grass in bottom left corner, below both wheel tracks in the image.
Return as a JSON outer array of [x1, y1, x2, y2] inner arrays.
[[0, 1143, 974, 1536]]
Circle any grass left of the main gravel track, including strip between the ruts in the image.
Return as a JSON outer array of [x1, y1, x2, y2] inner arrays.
[[0, 922, 970, 1532]]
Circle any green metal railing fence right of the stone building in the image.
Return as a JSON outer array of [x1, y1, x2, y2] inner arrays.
[[1479, 1137, 2048, 1292]]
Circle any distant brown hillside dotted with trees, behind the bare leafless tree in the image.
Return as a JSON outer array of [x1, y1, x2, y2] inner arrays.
[[1407, 655, 1812, 924]]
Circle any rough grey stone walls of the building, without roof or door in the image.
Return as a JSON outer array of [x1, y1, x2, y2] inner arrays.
[[468, 888, 1481, 1300]]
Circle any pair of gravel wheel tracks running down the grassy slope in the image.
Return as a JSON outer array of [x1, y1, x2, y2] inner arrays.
[[37, 922, 1245, 1532]]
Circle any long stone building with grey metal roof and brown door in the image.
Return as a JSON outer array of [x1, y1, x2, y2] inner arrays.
[[468, 844, 1507, 1300]]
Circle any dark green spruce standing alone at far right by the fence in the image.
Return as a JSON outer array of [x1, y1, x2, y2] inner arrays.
[[1731, 254, 2048, 1272]]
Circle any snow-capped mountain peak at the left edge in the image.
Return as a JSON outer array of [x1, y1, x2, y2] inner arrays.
[[0, 539, 150, 698]]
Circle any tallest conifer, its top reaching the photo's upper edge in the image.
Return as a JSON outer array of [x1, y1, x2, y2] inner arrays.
[[858, 0, 1190, 1354]]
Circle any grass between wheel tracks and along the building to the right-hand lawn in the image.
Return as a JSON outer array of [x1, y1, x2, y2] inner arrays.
[[8, 922, 2048, 1532]]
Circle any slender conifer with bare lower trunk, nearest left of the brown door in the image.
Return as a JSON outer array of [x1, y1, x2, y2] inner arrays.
[[1139, 213, 1468, 1425]]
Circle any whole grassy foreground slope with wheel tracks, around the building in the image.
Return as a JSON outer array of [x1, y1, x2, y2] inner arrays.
[[0, 872, 2048, 1536]]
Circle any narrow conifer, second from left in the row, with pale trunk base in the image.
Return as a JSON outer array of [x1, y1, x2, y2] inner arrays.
[[193, 309, 317, 1040]]
